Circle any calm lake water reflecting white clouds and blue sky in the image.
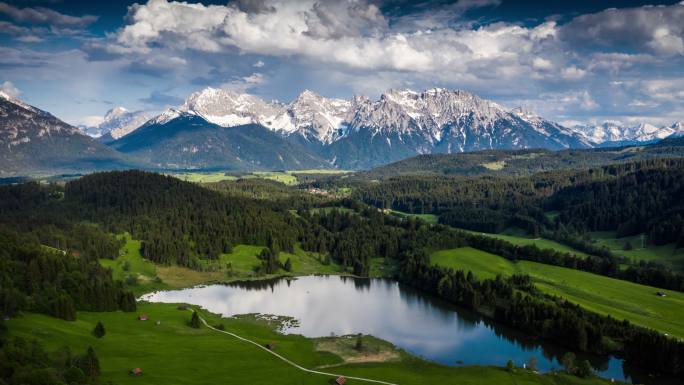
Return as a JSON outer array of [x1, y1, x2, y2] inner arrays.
[[141, 276, 668, 384]]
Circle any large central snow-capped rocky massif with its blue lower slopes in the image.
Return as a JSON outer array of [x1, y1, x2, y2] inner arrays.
[[144, 88, 591, 169]]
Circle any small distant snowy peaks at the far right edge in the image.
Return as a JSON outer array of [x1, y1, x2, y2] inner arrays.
[[573, 121, 684, 147]]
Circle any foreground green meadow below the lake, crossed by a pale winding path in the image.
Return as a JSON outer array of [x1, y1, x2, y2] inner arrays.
[[8, 304, 620, 385]]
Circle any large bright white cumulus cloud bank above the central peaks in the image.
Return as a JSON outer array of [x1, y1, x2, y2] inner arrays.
[[112, 0, 556, 75]]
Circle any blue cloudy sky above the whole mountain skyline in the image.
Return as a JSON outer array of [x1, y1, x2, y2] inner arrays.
[[0, 0, 684, 125]]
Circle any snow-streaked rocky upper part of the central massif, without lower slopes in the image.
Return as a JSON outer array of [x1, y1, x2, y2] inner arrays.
[[154, 88, 588, 152]]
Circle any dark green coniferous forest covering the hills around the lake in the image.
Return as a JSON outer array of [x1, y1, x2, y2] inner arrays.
[[0, 159, 684, 378]]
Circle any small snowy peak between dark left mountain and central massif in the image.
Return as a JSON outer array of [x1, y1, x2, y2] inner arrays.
[[81, 107, 151, 143]]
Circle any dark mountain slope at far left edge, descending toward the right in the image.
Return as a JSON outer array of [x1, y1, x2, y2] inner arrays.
[[0, 92, 132, 176]]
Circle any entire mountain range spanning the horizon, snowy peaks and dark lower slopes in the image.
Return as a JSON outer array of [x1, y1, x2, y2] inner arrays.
[[0, 88, 684, 174]]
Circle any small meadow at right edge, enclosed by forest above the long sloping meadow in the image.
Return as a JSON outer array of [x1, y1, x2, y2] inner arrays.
[[590, 231, 684, 271]]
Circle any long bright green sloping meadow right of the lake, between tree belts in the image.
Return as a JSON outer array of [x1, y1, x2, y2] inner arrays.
[[431, 247, 684, 338]]
